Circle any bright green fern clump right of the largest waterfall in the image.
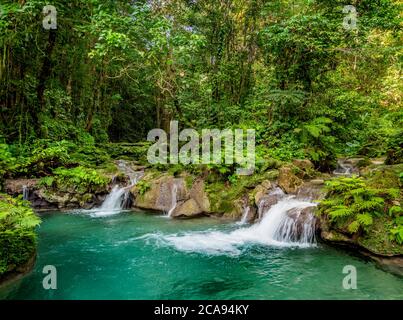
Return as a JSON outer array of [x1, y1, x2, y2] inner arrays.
[[318, 172, 403, 253]]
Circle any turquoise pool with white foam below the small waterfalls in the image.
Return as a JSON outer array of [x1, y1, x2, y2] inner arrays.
[[0, 210, 403, 299]]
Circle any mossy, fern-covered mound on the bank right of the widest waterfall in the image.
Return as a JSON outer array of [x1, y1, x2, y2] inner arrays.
[[318, 165, 403, 256]]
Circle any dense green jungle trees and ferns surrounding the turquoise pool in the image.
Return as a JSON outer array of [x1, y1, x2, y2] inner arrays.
[[0, 0, 403, 274]]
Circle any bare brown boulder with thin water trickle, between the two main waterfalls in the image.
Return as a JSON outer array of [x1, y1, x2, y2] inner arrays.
[[132, 175, 210, 218]]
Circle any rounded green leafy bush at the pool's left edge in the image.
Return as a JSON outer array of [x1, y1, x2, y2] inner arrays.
[[0, 194, 40, 279]]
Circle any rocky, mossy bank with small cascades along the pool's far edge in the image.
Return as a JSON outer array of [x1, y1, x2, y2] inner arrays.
[[1, 160, 403, 284]]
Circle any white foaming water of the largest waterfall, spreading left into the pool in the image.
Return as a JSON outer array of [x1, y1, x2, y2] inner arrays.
[[141, 197, 315, 255]]
